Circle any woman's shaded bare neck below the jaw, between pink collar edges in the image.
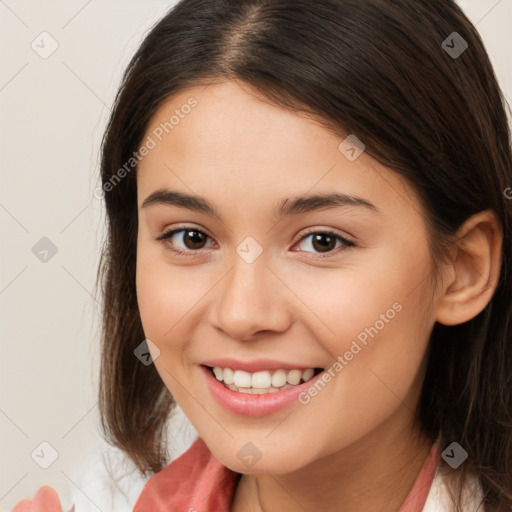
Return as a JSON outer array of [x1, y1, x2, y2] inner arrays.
[[231, 406, 432, 512]]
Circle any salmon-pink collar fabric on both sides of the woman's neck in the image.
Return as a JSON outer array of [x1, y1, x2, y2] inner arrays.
[[133, 438, 440, 512]]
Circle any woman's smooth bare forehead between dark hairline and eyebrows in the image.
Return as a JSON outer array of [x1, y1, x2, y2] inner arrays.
[[137, 82, 422, 220]]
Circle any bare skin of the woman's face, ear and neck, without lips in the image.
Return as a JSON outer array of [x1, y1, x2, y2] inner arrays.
[[137, 81, 501, 512]]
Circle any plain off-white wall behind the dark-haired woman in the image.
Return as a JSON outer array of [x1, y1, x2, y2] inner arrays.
[[0, 0, 512, 512]]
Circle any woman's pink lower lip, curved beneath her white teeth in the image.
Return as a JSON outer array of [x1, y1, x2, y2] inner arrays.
[[200, 365, 323, 417]]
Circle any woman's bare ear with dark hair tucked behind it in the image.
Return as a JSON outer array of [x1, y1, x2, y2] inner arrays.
[[436, 210, 503, 325]]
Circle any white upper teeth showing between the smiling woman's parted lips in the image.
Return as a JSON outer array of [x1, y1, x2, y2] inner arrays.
[[201, 365, 324, 395]]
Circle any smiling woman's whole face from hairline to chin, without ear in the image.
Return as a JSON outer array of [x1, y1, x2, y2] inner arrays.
[[137, 82, 435, 474]]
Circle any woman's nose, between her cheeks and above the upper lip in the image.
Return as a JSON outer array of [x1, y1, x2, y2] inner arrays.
[[211, 255, 292, 341]]
